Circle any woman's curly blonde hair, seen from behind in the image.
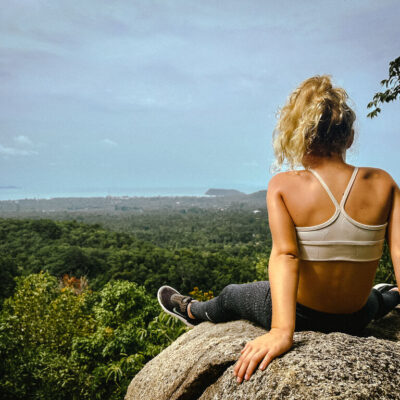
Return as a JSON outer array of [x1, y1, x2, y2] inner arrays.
[[273, 75, 356, 169]]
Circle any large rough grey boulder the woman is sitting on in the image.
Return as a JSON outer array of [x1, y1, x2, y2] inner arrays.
[[125, 307, 400, 400]]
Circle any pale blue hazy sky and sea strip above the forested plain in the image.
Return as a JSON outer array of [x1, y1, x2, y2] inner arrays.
[[0, 0, 400, 199]]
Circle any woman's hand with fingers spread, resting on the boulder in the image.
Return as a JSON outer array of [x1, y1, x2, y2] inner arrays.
[[233, 328, 293, 383]]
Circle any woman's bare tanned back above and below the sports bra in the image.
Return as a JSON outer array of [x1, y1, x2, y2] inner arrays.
[[279, 163, 394, 313]]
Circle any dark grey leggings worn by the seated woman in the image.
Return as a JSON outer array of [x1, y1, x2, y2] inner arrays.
[[190, 281, 400, 334]]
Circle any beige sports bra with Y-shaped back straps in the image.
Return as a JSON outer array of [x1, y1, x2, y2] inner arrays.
[[296, 168, 387, 262]]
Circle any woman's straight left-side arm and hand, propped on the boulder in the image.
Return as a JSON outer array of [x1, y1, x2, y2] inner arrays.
[[234, 174, 299, 383]]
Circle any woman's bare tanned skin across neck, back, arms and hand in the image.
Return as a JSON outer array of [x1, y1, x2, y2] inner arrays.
[[234, 152, 400, 383]]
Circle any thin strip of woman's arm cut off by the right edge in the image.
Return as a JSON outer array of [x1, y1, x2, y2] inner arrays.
[[387, 179, 400, 289]]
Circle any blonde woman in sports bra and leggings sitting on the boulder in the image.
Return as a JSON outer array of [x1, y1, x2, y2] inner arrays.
[[158, 76, 400, 383]]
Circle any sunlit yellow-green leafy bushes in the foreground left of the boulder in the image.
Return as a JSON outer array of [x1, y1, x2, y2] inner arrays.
[[0, 272, 186, 400]]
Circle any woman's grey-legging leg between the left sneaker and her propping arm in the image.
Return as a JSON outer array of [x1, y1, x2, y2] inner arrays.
[[190, 281, 272, 329]]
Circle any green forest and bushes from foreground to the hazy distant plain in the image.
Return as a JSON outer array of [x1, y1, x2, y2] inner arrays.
[[0, 209, 395, 400]]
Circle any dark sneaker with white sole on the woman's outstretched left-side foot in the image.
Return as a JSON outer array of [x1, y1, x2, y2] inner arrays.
[[157, 286, 203, 328]]
